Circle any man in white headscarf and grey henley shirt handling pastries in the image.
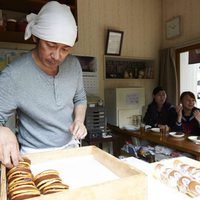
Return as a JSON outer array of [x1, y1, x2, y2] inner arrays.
[[0, 1, 87, 168]]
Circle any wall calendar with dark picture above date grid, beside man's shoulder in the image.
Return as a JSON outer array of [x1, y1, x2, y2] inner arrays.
[[76, 56, 99, 96]]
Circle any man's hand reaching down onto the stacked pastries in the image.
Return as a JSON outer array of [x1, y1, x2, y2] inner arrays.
[[0, 126, 23, 168]]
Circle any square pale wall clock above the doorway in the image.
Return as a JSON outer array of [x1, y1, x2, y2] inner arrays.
[[166, 16, 181, 39]]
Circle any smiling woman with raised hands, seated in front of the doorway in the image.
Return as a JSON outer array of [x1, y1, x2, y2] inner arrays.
[[175, 91, 200, 135]]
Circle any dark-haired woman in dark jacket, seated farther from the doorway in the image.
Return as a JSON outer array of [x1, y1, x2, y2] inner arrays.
[[143, 86, 176, 131]]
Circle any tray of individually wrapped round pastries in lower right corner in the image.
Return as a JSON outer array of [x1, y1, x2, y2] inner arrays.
[[153, 157, 200, 199]]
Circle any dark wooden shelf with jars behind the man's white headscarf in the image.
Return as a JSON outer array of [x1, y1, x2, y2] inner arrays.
[[0, 0, 77, 43]]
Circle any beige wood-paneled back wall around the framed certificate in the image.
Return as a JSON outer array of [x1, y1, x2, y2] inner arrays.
[[73, 0, 162, 106]]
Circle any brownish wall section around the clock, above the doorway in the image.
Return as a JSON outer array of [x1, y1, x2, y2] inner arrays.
[[162, 0, 200, 48]]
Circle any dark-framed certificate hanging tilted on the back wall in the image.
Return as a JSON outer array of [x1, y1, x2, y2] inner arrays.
[[105, 30, 124, 56]]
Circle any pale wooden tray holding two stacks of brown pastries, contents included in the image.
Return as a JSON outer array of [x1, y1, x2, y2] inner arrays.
[[1, 146, 147, 200]]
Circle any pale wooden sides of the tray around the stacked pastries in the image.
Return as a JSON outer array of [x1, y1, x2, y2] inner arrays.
[[1, 146, 147, 200]]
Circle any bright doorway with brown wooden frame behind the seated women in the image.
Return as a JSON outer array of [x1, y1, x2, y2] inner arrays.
[[175, 43, 200, 108]]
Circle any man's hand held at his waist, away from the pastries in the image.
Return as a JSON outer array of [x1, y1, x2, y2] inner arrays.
[[69, 120, 87, 139]]
